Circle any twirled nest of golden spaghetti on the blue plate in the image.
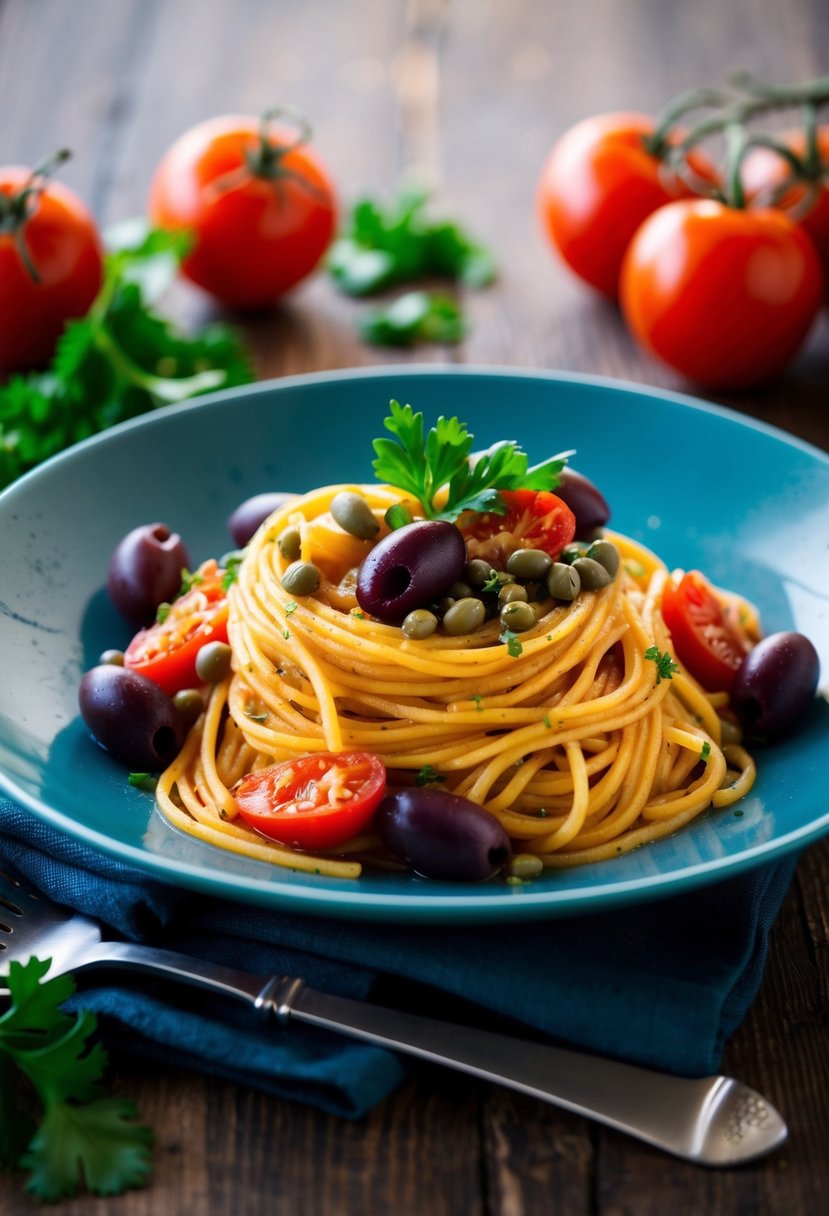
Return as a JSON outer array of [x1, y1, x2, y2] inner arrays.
[[157, 486, 755, 878]]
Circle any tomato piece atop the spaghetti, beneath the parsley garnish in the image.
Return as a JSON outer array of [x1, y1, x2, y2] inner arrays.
[[457, 490, 576, 565]]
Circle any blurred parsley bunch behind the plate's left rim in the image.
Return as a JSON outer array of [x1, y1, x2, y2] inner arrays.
[[0, 231, 253, 489]]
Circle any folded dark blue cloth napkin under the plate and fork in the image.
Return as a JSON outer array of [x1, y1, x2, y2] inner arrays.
[[0, 798, 797, 1116]]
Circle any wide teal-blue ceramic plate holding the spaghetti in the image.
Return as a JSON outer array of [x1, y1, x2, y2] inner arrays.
[[0, 367, 829, 922]]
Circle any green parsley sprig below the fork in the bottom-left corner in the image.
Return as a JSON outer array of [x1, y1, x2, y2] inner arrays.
[[0, 958, 152, 1203]]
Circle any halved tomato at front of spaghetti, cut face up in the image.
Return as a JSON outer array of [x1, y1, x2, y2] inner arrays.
[[233, 751, 385, 851]]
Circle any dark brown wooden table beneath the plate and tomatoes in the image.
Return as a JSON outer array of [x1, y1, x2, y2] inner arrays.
[[0, 0, 829, 1216]]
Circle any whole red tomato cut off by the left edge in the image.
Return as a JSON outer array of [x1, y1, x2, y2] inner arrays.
[[0, 158, 103, 373]]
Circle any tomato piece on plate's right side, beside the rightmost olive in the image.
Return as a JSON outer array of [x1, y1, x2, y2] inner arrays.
[[662, 570, 751, 692]]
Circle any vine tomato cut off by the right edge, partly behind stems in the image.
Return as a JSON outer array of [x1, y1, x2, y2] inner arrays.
[[743, 126, 829, 283]]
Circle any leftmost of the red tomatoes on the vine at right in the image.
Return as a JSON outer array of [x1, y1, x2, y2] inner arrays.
[[537, 113, 714, 299]]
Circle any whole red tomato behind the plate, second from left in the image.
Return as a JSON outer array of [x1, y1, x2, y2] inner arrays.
[[148, 116, 335, 309]]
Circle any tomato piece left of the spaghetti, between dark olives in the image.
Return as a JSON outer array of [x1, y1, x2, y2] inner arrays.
[[124, 558, 227, 696]]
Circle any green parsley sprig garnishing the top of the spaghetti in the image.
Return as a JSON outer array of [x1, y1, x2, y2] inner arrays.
[[373, 401, 569, 520]]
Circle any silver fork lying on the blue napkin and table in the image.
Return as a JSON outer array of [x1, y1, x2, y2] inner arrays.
[[0, 871, 786, 1166]]
